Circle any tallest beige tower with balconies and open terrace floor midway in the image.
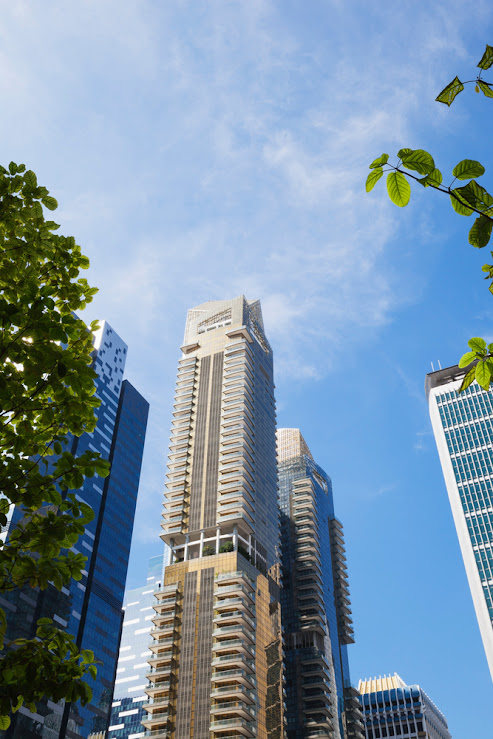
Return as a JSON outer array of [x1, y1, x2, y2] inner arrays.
[[144, 296, 283, 739]]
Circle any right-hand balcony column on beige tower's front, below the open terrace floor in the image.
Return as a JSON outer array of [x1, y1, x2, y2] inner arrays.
[[210, 572, 256, 739]]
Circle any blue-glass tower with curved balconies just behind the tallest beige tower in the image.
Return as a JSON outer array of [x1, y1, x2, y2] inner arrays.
[[277, 429, 363, 739]]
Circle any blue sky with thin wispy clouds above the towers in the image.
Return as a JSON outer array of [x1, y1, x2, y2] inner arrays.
[[0, 0, 493, 739]]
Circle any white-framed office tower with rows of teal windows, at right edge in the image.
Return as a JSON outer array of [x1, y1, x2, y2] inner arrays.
[[426, 367, 493, 678]]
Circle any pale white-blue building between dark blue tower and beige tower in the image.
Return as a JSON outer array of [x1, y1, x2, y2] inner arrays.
[[107, 555, 165, 739]]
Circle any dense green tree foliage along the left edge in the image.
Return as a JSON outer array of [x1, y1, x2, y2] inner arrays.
[[0, 162, 109, 728]]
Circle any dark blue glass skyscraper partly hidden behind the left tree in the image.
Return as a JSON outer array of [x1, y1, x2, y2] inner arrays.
[[2, 322, 149, 739]]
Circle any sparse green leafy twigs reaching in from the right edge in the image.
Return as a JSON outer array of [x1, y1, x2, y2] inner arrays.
[[366, 45, 493, 392]]
